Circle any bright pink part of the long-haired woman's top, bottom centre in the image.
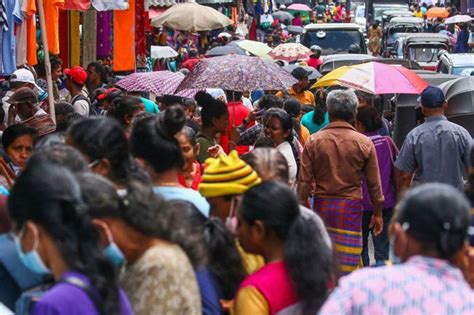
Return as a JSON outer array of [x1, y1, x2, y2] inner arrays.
[[235, 261, 298, 315]]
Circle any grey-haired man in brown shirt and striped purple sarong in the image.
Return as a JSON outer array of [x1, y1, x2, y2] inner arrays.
[[298, 90, 384, 274]]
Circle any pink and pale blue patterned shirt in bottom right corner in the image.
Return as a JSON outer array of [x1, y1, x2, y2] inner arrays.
[[319, 256, 474, 315]]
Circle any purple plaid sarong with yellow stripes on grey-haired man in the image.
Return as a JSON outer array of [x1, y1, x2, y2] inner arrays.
[[314, 198, 363, 274]]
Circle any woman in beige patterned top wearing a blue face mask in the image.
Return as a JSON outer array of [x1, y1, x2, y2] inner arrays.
[[79, 174, 201, 315]]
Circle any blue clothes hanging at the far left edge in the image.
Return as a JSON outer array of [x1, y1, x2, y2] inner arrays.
[[2, 0, 22, 74]]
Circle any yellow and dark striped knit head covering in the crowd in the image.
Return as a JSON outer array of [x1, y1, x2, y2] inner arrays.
[[199, 151, 262, 198]]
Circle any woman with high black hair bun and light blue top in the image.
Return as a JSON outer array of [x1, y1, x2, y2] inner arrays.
[[130, 106, 209, 216]]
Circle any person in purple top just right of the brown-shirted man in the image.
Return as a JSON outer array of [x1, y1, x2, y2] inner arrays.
[[356, 106, 398, 266]]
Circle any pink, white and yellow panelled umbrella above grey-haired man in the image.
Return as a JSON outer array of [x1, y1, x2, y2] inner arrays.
[[312, 62, 428, 94]]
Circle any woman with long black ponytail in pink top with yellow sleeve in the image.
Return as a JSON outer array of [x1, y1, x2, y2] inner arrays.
[[234, 181, 332, 315]]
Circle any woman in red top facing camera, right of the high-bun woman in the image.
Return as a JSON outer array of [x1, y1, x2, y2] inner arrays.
[[176, 126, 202, 190]]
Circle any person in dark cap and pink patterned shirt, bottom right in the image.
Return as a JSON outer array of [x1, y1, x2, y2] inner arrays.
[[320, 183, 474, 314]]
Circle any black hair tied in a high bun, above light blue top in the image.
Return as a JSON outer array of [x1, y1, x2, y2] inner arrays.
[[130, 106, 186, 173]]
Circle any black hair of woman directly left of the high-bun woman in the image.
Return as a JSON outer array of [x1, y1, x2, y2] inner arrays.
[[67, 117, 138, 185]]
